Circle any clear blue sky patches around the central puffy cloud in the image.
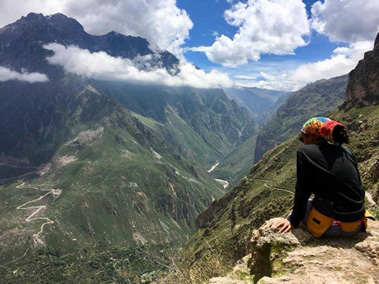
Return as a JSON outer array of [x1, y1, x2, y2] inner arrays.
[[177, 0, 354, 87]]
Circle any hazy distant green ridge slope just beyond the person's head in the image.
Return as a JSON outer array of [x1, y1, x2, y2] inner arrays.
[[254, 75, 348, 162]]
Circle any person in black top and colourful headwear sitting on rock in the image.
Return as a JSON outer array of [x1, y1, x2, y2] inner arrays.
[[275, 117, 367, 237]]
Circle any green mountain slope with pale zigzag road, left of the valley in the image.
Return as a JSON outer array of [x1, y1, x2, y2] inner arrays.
[[0, 77, 223, 261]]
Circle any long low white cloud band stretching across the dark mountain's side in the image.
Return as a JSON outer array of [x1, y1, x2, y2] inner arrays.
[[44, 43, 233, 88]]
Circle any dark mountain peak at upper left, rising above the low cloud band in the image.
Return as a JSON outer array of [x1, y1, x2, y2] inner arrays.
[[0, 13, 178, 74]]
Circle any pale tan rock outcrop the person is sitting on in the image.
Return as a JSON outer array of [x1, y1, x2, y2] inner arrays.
[[210, 219, 379, 284]]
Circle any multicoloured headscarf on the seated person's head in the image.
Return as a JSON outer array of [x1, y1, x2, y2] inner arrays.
[[301, 117, 345, 143]]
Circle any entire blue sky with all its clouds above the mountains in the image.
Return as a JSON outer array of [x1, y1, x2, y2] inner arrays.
[[0, 0, 379, 91]]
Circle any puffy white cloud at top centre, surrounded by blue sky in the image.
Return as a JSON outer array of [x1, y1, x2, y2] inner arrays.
[[191, 0, 310, 66]]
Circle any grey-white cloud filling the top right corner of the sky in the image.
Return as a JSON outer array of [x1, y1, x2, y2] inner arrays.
[[311, 0, 379, 43]]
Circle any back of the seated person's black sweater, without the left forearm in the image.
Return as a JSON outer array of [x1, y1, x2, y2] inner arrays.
[[295, 141, 365, 222]]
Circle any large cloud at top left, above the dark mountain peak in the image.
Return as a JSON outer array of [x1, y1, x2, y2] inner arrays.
[[0, 0, 193, 56]]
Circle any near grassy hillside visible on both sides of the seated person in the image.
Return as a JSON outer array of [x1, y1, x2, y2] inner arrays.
[[181, 36, 379, 283]]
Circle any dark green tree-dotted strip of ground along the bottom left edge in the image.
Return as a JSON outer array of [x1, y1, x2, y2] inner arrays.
[[0, 243, 170, 284]]
